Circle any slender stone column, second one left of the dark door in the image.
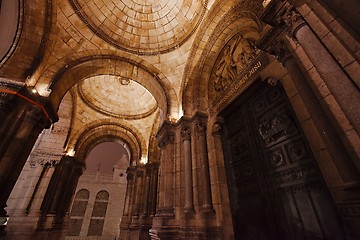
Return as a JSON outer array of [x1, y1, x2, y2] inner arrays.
[[196, 122, 214, 212]]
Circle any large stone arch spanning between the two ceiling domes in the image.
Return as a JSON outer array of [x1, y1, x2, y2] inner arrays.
[[36, 53, 179, 123]]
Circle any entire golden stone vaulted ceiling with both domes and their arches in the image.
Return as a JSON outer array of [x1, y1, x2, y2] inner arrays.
[[0, 0, 262, 164]]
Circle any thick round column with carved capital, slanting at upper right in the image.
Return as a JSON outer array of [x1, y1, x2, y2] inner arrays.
[[263, 1, 360, 134]]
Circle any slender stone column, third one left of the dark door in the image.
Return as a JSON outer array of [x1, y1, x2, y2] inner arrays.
[[181, 126, 194, 213]]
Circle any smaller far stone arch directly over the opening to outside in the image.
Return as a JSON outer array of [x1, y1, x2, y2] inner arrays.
[[71, 121, 147, 164]]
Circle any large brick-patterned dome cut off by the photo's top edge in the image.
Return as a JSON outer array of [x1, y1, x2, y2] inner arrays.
[[69, 0, 207, 54]]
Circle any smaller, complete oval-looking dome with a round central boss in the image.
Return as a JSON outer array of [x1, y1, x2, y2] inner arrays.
[[78, 75, 157, 119]]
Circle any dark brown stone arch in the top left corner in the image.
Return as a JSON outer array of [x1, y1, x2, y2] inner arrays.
[[0, 0, 52, 81]]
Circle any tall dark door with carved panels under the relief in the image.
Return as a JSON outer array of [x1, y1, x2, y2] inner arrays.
[[222, 82, 342, 240]]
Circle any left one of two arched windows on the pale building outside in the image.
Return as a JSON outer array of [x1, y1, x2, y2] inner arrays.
[[68, 189, 90, 236]]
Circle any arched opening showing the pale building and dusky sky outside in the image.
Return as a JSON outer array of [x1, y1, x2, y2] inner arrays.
[[67, 140, 130, 239]]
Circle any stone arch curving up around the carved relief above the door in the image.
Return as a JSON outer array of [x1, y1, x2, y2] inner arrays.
[[181, 1, 262, 115]]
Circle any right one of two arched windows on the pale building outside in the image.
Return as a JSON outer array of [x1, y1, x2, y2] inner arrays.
[[88, 190, 109, 236]]
